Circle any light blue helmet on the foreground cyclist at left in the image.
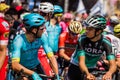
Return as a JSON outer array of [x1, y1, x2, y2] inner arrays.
[[23, 13, 45, 30]]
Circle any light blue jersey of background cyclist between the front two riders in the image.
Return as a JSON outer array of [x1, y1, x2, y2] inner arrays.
[[45, 22, 61, 53]]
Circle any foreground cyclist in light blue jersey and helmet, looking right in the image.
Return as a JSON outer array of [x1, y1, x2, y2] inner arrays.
[[11, 13, 59, 80]]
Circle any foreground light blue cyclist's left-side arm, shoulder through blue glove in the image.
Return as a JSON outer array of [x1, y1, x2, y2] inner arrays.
[[11, 37, 42, 80]]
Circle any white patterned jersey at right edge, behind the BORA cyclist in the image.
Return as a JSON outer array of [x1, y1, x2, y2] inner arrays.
[[105, 34, 120, 58]]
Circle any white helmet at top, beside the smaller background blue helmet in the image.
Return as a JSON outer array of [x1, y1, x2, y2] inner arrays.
[[39, 2, 54, 13]]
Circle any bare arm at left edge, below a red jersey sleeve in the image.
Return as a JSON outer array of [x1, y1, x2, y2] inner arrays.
[[0, 45, 7, 69]]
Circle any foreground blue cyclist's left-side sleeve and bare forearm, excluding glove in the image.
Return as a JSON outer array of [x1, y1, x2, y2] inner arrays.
[[10, 36, 33, 75]]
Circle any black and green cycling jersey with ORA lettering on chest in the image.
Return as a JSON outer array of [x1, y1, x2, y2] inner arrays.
[[71, 36, 114, 68]]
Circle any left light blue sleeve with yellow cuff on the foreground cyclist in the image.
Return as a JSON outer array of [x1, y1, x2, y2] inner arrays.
[[11, 36, 24, 62]]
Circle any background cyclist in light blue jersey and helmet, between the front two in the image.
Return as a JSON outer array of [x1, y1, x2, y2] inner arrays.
[[45, 5, 63, 54]]
